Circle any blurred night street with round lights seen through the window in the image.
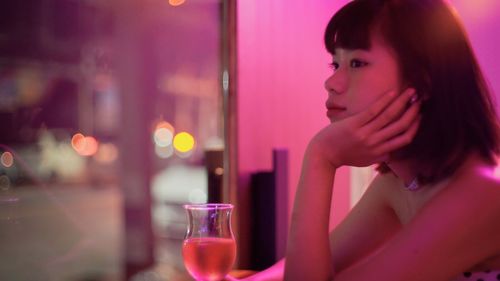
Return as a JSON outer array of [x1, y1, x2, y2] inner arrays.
[[0, 0, 227, 280]]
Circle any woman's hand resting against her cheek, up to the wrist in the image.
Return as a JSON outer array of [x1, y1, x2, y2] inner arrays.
[[308, 88, 420, 168]]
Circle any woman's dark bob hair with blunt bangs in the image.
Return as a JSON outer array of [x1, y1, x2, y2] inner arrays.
[[324, 0, 499, 184]]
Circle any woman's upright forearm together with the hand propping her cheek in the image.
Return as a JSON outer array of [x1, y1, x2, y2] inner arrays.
[[285, 90, 419, 280]]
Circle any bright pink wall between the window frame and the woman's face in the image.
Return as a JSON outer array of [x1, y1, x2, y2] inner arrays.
[[237, 0, 349, 241]]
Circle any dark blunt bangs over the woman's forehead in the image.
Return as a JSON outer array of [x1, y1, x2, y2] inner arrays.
[[324, 0, 384, 54]]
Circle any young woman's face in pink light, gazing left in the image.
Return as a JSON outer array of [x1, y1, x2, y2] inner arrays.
[[325, 36, 401, 122]]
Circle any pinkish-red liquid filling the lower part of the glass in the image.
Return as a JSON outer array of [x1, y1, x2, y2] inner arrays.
[[182, 237, 236, 281]]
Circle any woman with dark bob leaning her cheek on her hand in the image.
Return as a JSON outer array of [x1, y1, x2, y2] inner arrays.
[[237, 0, 500, 281]]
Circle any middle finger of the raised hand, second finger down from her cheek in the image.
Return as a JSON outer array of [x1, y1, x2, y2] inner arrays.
[[364, 88, 416, 133]]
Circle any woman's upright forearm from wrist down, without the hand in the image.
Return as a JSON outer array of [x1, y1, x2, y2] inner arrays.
[[285, 145, 336, 280]]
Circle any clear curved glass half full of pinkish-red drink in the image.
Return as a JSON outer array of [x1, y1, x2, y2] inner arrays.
[[182, 204, 236, 281]]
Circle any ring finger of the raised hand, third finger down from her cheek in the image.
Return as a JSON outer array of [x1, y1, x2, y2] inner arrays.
[[370, 98, 420, 145]]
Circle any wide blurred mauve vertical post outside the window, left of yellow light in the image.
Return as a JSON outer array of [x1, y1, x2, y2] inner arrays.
[[115, 0, 155, 280]]
